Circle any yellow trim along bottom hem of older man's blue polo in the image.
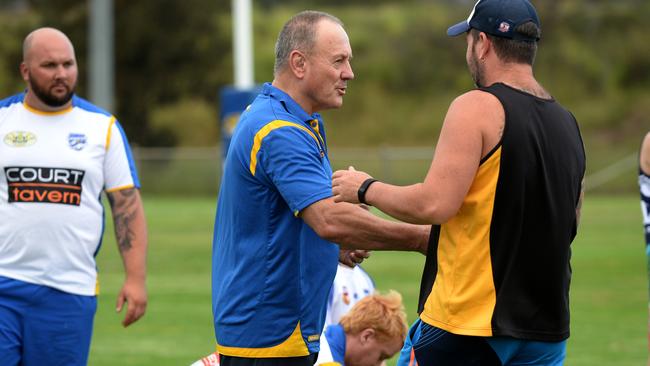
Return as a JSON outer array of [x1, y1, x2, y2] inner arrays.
[[217, 322, 309, 358]]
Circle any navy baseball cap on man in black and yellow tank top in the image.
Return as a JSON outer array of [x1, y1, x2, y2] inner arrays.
[[447, 0, 541, 42]]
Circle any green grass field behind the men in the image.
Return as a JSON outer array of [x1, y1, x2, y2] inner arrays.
[[89, 195, 648, 366]]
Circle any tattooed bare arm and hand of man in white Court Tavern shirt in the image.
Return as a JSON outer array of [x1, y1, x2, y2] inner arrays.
[[107, 188, 147, 327]]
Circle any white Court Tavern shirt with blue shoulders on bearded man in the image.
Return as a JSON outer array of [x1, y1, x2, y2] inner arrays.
[[0, 94, 140, 295]]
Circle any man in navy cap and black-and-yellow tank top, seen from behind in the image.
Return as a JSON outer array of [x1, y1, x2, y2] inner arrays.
[[333, 0, 585, 366]]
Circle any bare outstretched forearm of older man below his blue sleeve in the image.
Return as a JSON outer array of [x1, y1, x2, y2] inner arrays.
[[300, 197, 431, 254]]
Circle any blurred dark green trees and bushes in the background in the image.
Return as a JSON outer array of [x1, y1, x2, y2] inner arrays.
[[0, 0, 650, 159]]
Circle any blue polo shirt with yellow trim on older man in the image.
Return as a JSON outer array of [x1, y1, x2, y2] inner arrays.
[[212, 83, 339, 357]]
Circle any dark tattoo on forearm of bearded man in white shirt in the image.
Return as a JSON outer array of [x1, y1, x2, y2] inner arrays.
[[108, 188, 137, 252]]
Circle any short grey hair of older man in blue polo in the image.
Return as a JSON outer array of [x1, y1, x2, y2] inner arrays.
[[273, 10, 343, 75]]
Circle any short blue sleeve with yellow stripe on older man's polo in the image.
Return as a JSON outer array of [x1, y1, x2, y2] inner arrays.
[[258, 126, 332, 214]]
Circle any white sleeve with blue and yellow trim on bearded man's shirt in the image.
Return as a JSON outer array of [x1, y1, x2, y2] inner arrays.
[[104, 117, 140, 192]]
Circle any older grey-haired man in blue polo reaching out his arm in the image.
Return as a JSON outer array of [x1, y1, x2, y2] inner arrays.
[[212, 11, 429, 366]]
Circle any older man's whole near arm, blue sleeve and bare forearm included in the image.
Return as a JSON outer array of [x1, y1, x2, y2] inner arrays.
[[252, 122, 431, 254]]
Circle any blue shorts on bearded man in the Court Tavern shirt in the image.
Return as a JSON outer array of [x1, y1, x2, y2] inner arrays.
[[0, 276, 97, 366]]
